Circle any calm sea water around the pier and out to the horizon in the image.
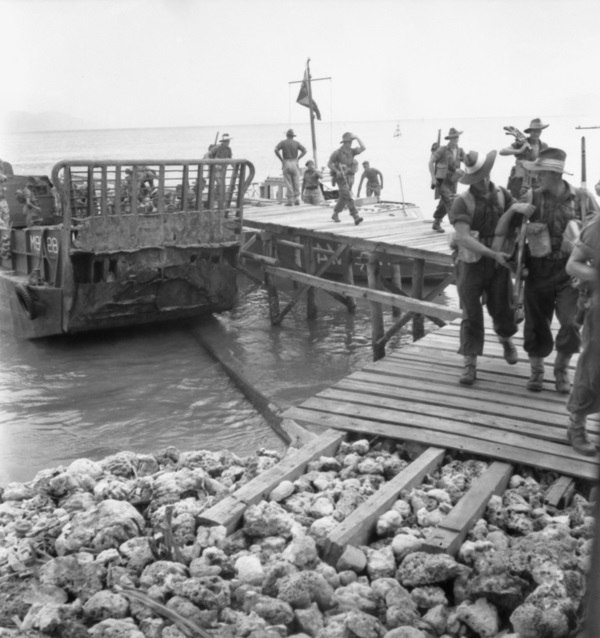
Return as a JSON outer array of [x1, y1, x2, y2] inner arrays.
[[0, 114, 600, 485]]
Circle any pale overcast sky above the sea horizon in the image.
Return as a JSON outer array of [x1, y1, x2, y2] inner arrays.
[[0, 0, 600, 128]]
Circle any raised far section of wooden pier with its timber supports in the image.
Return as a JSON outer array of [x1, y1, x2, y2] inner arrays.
[[241, 203, 461, 360]]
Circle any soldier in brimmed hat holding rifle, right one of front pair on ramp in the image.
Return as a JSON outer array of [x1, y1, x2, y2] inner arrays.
[[502, 148, 600, 402]]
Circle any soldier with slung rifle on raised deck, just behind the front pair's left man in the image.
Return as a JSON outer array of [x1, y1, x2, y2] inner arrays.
[[429, 128, 465, 233]]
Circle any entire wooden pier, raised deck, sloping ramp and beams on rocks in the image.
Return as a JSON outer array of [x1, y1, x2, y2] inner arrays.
[[206, 199, 600, 565]]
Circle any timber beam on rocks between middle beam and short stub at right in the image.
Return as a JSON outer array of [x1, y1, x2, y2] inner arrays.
[[423, 462, 513, 554]]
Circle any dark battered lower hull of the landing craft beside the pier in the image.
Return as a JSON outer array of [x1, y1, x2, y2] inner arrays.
[[0, 260, 237, 339]]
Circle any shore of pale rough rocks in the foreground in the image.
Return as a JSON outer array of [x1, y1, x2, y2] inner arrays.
[[0, 439, 594, 638]]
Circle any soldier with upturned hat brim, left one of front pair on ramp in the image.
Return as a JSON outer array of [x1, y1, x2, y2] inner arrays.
[[449, 151, 528, 385]]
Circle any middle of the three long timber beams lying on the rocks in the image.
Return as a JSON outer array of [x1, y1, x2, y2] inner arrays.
[[324, 447, 444, 566]]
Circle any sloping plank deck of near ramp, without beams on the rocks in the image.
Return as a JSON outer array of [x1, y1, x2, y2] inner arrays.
[[284, 321, 600, 481]]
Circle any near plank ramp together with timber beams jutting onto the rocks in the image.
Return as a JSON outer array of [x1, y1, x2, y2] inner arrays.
[[200, 321, 600, 565]]
